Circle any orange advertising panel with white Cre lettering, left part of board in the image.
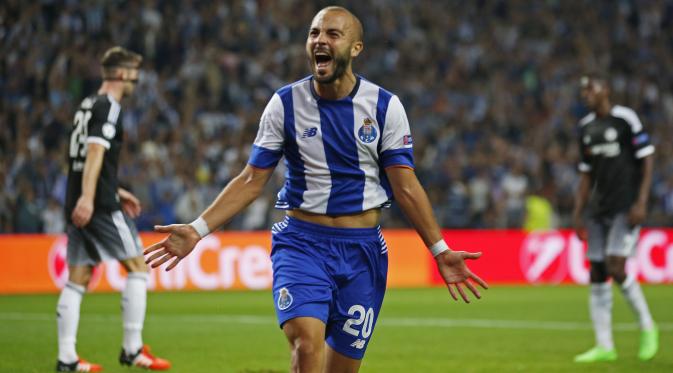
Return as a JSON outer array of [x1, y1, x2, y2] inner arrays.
[[0, 230, 430, 294]]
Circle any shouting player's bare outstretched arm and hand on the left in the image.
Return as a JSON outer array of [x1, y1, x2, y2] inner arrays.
[[144, 165, 273, 271]]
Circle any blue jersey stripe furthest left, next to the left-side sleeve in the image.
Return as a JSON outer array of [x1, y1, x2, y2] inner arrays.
[[277, 86, 306, 208]]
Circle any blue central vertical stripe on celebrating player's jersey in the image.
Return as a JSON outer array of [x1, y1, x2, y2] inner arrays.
[[318, 97, 365, 215]]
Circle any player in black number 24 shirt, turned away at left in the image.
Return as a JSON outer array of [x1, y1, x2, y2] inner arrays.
[[56, 47, 170, 372]]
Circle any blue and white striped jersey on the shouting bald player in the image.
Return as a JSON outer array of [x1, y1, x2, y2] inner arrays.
[[248, 76, 414, 215]]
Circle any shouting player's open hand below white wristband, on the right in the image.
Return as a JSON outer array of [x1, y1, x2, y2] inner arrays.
[[435, 250, 488, 303]]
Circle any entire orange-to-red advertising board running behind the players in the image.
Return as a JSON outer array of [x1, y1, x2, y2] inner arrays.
[[0, 229, 673, 294]]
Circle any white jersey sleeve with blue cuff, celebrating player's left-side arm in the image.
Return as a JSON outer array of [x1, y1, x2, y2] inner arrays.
[[248, 94, 285, 168]]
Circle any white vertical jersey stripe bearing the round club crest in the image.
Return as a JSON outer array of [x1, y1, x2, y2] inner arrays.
[[352, 81, 388, 211]]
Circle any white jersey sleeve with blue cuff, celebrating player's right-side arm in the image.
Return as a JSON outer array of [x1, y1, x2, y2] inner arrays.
[[380, 96, 414, 168]]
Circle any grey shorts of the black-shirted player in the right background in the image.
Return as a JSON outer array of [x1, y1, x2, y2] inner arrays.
[[587, 213, 640, 262]]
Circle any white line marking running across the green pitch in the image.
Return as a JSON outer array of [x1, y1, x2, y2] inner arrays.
[[0, 312, 673, 331]]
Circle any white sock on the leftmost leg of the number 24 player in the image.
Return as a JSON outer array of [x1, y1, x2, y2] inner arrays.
[[56, 281, 86, 363]]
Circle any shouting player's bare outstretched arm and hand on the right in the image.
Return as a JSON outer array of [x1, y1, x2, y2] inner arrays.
[[386, 167, 488, 303]]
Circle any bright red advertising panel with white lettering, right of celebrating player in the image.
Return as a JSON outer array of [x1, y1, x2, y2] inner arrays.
[[431, 229, 673, 284]]
